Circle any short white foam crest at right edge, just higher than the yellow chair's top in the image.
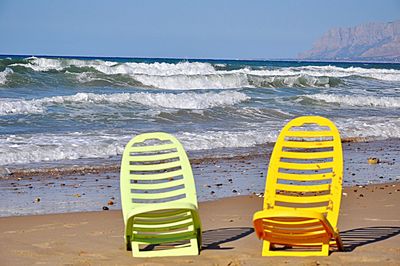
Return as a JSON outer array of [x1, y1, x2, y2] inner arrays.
[[304, 94, 400, 108]]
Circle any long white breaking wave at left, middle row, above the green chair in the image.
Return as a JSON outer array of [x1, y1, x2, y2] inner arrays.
[[0, 91, 250, 115]]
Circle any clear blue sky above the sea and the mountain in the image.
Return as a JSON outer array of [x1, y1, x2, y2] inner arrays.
[[0, 0, 400, 58]]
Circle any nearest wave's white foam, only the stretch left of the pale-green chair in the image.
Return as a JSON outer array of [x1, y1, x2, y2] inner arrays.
[[0, 132, 129, 165]]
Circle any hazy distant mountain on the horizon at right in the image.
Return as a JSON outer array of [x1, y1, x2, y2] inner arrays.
[[298, 20, 400, 62]]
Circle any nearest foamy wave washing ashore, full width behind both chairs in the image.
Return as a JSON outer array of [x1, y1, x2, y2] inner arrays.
[[0, 117, 400, 165]]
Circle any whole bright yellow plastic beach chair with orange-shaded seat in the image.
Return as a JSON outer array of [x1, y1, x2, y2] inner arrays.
[[253, 116, 343, 256]]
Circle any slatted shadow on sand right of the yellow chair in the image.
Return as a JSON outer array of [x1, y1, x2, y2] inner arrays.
[[340, 226, 400, 252]]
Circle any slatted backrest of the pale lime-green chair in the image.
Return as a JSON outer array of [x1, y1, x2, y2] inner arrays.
[[120, 132, 197, 221]]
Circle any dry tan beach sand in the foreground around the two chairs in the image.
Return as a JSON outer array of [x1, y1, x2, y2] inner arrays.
[[0, 183, 400, 265]]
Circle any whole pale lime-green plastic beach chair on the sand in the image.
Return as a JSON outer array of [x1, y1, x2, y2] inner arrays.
[[120, 132, 201, 257]]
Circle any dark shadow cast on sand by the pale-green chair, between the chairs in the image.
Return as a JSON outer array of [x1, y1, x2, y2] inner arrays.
[[202, 227, 254, 249]]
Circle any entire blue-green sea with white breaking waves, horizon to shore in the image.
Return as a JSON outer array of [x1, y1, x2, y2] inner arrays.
[[0, 56, 400, 166]]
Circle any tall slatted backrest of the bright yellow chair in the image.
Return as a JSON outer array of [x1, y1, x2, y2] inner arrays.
[[264, 116, 343, 226]]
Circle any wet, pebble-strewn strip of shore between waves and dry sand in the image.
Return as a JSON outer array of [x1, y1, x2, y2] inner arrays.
[[0, 139, 400, 217]]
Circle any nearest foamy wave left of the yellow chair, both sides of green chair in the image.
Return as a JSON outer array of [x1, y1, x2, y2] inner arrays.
[[0, 130, 276, 165]]
